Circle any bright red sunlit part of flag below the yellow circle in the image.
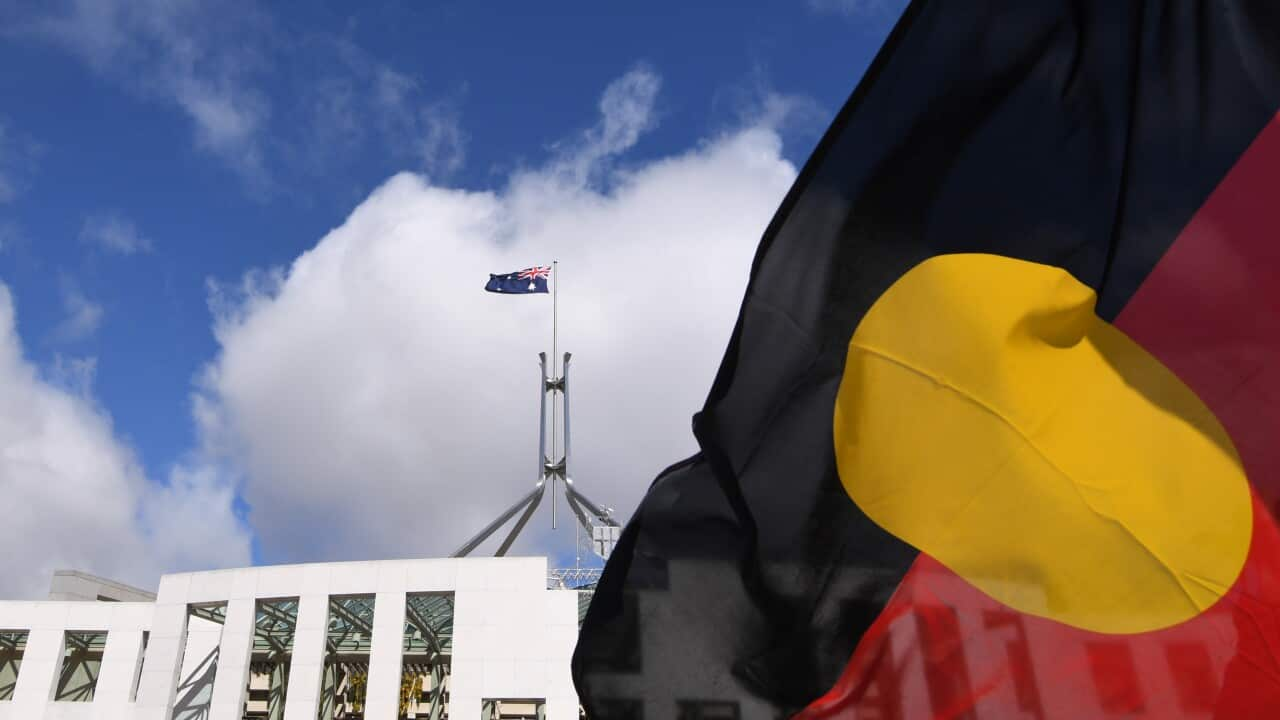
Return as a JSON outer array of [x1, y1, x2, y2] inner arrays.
[[797, 501, 1280, 720]]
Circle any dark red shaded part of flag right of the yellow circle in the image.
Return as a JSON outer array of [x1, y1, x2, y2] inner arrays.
[[1116, 113, 1280, 514]]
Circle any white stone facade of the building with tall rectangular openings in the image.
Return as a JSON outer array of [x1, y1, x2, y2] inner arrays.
[[0, 557, 579, 720]]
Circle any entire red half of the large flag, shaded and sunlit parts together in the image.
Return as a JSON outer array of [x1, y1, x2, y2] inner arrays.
[[799, 114, 1280, 720]]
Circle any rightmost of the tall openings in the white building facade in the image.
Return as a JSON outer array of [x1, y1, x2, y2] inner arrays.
[[399, 593, 453, 719]]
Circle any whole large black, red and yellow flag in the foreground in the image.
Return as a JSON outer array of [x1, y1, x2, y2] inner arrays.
[[573, 0, 1280, 720]]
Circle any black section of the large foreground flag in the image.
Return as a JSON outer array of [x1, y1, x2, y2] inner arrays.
[[573, 0, 1280, 720]]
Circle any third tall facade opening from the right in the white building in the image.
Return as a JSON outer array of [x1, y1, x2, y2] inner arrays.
[[241, 597, 298, 720]]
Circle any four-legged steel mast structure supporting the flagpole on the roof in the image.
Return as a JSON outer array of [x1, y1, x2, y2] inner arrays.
[[449, 352, 621, 559]]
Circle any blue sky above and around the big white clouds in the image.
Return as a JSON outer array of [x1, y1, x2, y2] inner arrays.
[[0, 0, 901, 592]]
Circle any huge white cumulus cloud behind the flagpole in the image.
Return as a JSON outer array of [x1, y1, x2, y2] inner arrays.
[[196, 69, 795, 561]]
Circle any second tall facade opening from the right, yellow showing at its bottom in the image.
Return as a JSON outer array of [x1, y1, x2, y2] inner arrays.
[[316, 596, 374, 720]]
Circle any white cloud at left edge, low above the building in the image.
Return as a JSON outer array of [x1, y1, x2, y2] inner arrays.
[[0, 283, 250, 598]]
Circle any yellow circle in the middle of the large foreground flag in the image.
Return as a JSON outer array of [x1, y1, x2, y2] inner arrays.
[[833, 255, 1253, 633]]
